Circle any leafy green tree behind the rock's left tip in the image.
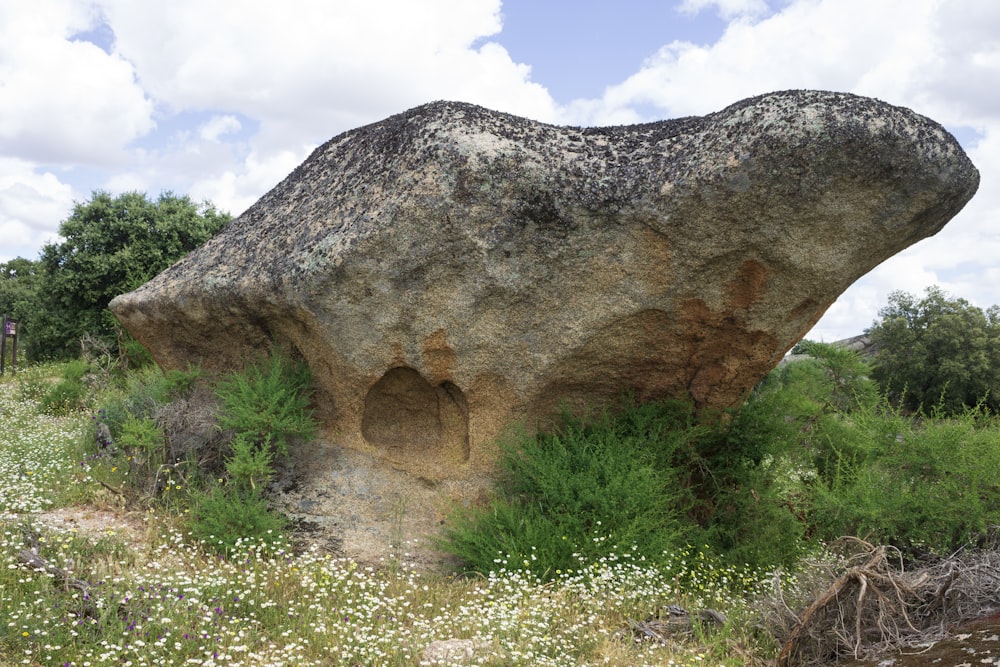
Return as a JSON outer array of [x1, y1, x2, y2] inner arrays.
[[29, 192, 230, 358]]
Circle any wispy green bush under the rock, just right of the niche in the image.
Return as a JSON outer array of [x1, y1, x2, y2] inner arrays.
[[444, 406, 690, 576]]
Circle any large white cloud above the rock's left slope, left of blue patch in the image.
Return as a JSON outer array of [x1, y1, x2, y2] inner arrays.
[[82, 0, 558, 219]]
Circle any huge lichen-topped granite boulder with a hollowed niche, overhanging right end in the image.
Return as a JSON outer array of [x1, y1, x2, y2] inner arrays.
[[111, 91, 979, 477]]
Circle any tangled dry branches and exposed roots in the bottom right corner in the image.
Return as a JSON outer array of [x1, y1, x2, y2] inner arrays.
[[763, 538, 1000, 667]]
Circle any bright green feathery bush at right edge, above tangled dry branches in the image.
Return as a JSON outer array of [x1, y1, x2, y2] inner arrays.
[[810, 404, 1000, 557]]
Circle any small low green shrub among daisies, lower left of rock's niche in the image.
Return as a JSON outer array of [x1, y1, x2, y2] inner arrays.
[[190, 486, 288, 554]]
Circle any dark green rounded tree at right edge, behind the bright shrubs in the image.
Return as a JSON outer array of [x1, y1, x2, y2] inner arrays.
[[867, 286, 1000, 414]]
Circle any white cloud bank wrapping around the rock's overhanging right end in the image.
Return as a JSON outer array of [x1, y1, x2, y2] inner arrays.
[[566, 0, 1000, 340]]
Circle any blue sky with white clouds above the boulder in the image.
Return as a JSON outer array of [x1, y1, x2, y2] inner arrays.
[[0, 0, 1000, 342]]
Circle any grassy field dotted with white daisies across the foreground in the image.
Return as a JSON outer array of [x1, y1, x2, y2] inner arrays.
[[0, 368, 777, 667]]
